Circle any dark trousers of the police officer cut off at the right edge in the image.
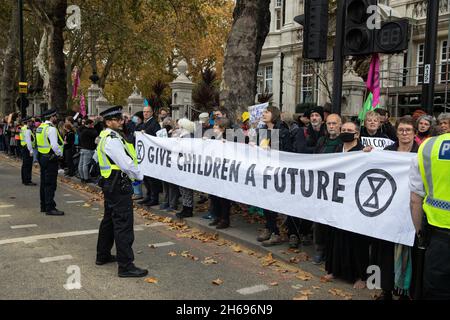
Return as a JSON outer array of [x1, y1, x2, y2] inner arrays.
[[423, 227, 450, 300]]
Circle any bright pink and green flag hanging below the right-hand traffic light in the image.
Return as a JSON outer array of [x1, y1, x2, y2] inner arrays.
[[358, 53, 381, 123]]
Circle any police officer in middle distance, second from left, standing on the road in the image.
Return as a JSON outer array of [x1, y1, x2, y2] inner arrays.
[[36, 109, 64, 216]]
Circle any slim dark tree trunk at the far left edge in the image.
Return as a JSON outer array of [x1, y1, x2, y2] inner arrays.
[[0, 1, 19, 115]]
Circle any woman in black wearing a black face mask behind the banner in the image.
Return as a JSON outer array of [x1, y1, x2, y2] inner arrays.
[[325, 122, 369, 289]]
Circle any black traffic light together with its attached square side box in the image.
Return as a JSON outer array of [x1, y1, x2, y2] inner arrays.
[[344, 0, 409, 56]]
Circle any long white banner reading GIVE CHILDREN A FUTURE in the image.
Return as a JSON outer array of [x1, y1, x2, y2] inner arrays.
[[136, 133, 416, 246]]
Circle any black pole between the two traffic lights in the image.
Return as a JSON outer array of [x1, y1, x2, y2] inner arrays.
[[332, 0, 345, 114]]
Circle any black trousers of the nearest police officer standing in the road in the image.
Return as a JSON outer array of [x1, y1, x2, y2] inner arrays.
[[97, 171, 134, 270]]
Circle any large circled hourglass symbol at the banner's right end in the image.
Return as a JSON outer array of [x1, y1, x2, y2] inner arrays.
[[355, 169, 397, 217]]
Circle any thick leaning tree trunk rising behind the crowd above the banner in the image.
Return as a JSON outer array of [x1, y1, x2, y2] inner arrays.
[[220, 0, 270, 114]]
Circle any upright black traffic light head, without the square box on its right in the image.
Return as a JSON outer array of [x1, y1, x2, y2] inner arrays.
[[344, 0, 377, 56]]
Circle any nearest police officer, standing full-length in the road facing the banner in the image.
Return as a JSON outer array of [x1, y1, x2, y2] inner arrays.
[[96, 106, 148, 278]]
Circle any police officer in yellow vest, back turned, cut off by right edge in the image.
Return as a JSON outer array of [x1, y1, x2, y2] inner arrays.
[[410, 133, 450, 300]]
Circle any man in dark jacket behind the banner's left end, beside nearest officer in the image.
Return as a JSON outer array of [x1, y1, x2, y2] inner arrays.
[[136, 106, 161, 207]]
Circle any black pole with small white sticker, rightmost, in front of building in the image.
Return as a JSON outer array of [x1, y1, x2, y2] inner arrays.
[[421, 0, 439, 114]]
